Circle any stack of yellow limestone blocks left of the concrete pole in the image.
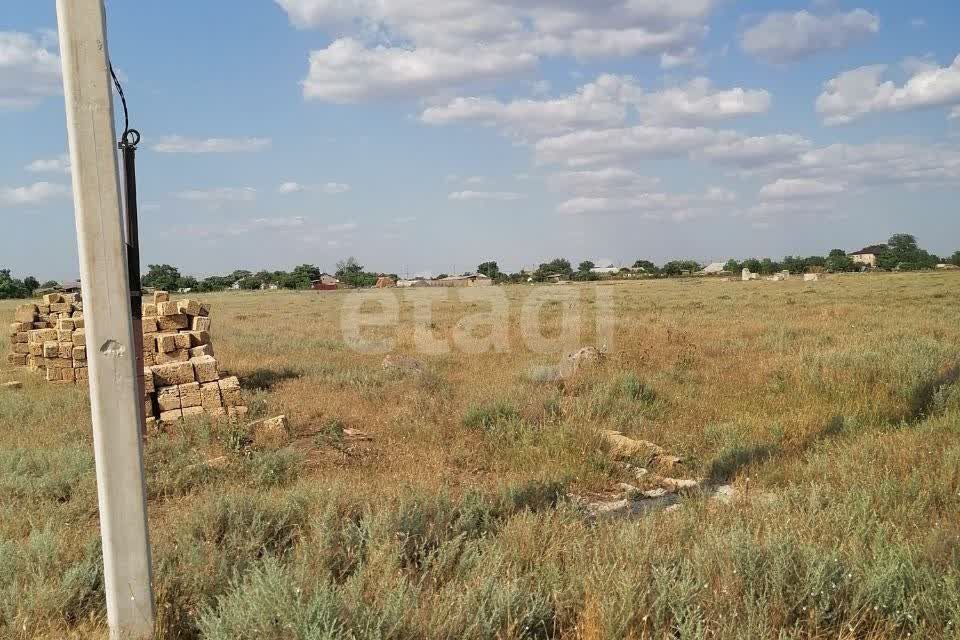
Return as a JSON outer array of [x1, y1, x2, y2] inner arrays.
[[7, 293, 87, 382]]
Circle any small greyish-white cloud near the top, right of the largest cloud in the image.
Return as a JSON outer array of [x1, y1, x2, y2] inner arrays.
[[741, 9, 880, 64]]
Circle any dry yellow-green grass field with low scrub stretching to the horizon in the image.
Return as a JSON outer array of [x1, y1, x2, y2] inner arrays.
[[0, 273, 960, 640]]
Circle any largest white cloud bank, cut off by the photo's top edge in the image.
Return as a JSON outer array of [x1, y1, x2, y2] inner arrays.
[[276, 0, 718, 103]]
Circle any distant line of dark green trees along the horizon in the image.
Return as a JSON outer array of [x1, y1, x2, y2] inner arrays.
[[0, 233, 960, 300]]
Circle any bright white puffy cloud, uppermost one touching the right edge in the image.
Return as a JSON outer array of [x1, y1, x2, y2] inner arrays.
[[816, 56, 960, 125]]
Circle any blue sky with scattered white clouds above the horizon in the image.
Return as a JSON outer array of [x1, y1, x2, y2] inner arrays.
[[0, 0, 960, 279]]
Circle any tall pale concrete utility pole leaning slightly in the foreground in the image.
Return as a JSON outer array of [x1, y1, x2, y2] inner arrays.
[[57, 0, 153, 640]]
